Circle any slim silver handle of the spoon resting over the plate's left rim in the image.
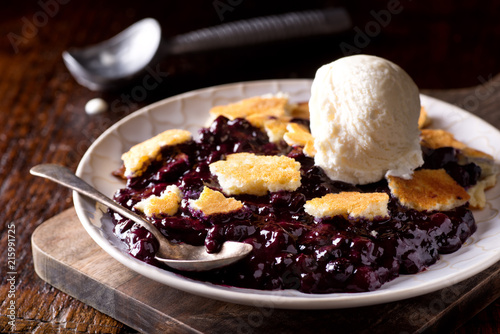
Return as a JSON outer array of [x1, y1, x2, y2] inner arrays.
[[30, 164, 168, 242]]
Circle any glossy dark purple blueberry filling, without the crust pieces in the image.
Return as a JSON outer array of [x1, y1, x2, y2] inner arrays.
[[112, 117, 481, 293]]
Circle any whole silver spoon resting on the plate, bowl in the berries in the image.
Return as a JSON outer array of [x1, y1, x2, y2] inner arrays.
[[30, 164, 253, 271]]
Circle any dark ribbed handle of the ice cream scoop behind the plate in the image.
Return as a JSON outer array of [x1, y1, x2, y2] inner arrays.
[[166, 8, 352, 54]]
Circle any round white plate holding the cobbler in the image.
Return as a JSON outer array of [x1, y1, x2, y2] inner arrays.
[[73, 80, 500, 309]]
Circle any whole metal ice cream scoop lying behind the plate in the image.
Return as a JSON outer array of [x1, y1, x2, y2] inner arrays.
[[63, 8, 351, 90]]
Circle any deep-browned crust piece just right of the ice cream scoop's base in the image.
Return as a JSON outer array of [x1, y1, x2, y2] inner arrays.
[[387, 169, 470, 211]]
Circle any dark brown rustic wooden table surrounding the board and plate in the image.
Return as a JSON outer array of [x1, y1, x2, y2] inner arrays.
[[0, 0, 500, 333]]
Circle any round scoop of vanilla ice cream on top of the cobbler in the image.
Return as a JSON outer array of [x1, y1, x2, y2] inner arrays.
[[309, 55, 423, 184]]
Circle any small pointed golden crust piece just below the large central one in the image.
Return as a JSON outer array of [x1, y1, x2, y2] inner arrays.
[[189, 187, 243, 216]]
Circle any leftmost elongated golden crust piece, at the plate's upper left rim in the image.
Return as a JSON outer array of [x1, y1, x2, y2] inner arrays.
[[122, 129, 192, 177]]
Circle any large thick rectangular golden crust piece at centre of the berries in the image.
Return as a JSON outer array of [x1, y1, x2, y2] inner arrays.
[[209, 153, 300, 196]]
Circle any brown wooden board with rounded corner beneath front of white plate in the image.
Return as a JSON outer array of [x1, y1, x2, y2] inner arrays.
[[32, 209, 500, 334]]
